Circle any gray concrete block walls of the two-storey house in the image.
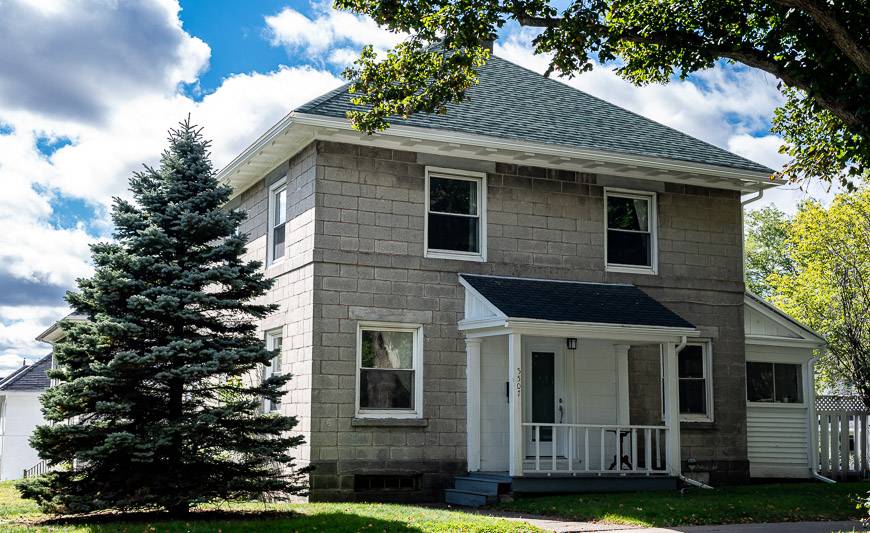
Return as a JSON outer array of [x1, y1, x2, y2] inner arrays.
[[235, 141, 748, 499]]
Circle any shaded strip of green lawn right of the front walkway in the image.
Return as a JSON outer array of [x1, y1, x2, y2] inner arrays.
[[493, 482, 870, 526]]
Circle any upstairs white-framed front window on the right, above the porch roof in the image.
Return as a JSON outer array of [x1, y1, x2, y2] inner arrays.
[[604, 189, 658, 274]]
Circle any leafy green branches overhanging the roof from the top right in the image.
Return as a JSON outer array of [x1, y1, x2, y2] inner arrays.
[[335, 0, 870, 187]]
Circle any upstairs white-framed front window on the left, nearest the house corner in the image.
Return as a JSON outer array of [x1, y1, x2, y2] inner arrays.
[[424, 167, 486, 261]]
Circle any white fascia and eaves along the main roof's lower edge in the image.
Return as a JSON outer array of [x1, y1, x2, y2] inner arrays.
[[217, 112, 783, 192]]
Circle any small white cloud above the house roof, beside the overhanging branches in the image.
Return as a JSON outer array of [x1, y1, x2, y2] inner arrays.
[[266, 3, 405, 65]]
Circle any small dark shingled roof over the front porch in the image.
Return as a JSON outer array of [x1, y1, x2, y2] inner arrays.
[[460, 274, 695, 328]]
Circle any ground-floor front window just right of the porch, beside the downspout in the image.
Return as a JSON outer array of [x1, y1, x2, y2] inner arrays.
[[677, 342, 713, 421]]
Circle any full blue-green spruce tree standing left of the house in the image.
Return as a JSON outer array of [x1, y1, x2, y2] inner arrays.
[[20, 120, 303, 513]]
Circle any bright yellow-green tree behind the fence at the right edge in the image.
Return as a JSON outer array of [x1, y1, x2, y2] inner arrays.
[[746, 189, 870, 407]]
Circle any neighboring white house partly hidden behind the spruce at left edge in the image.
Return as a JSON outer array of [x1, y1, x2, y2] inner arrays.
[[0, 355, 51, 481]]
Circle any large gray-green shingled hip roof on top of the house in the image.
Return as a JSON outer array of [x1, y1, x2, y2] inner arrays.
[[296, 53, 773, 172]]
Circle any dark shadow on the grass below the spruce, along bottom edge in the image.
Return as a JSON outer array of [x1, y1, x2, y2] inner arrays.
[[16, 510, 423, 533]]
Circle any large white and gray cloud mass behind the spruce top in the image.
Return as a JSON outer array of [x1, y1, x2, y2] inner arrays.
[[0, 0, 341, 376]]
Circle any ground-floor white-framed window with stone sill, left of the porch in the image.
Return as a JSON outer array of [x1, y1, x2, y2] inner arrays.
[[356, 322, 423, 418]]
